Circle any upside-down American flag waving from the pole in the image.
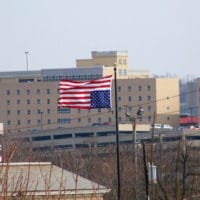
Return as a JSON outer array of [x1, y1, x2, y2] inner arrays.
[[58, 76, 112, 109]]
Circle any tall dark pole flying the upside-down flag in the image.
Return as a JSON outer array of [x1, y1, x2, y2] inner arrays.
[[114, 64, 121, 200]]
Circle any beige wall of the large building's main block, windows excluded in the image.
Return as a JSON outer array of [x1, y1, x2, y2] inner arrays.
[[0, 75, 179, 131]]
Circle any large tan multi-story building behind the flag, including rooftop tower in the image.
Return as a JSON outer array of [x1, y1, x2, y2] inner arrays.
[[0, 51, 179, 132]]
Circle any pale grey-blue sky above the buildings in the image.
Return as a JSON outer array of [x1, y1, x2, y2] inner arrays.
[[0, 0, 200, 77]]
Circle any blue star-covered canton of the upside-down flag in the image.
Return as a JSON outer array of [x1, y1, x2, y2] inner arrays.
[[90, 90, 111, 109]]
